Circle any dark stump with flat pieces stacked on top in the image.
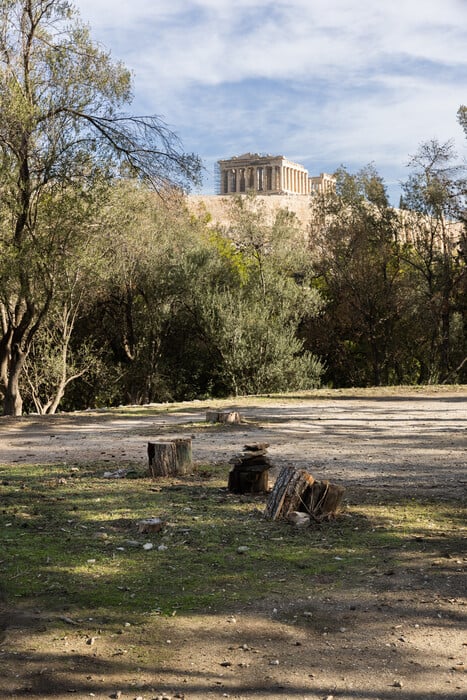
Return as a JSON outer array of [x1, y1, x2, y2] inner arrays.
[[228, 442, 272, 493]]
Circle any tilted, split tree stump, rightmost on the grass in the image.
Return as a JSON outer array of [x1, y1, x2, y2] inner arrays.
[[264, 467, 344, 521]]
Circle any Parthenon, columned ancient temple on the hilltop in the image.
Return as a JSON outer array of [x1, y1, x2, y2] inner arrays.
[[218, 153, 334, 195]]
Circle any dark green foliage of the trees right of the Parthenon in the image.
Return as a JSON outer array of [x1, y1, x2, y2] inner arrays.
[[303, 158, 467, 386]]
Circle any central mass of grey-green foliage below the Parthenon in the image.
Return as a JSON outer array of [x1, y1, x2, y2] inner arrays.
[[65, 189, 322, 403]]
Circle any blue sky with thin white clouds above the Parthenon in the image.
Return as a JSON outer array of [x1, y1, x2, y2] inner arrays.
[[74, 0, 467, 204]]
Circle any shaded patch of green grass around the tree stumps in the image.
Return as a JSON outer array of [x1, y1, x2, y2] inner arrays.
[[0, 464, 462, 619]]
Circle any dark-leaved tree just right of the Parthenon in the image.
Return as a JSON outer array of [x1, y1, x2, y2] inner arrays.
[[306, 165, 406, 386]]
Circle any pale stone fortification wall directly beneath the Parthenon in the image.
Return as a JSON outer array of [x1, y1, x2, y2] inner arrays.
[[187, 194, 311, 230]]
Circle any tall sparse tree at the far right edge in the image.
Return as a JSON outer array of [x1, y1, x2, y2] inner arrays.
[[401, 139, 466, 382]]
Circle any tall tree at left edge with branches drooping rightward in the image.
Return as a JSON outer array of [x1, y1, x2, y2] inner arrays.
[[0, 0, 199, 415]]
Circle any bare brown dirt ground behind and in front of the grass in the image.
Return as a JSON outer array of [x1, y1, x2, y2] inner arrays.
[[0, 387, 467, 700]]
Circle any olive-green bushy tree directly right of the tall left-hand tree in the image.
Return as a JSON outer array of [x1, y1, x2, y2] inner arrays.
[[75, 181, 204, 403]]
